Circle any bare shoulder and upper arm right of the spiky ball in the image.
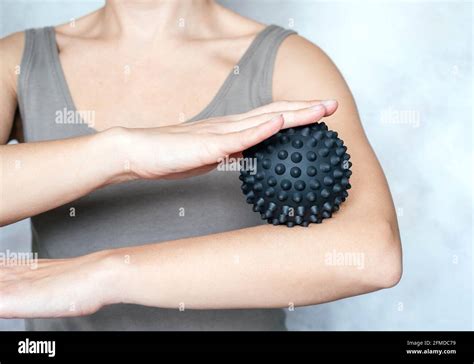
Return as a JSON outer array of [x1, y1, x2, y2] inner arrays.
[[273, 35, 398, 230]]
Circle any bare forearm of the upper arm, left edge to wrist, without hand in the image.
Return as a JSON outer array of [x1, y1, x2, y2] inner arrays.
[[0, 129, 127, 225]]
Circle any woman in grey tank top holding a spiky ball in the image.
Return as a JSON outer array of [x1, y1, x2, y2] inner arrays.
[[0, 0, 401, 330]]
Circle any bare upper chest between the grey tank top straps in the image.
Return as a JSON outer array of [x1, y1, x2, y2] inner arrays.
[[59, 39, 241, 130]]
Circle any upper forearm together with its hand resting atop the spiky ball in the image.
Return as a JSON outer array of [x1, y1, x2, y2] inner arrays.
[[0, 101, 337, 226]]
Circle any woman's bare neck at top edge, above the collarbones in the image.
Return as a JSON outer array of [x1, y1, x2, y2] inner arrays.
[[101, 0, 217, 40]]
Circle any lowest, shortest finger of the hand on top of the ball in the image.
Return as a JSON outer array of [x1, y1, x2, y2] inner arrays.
[[215, 115, 283, 155]]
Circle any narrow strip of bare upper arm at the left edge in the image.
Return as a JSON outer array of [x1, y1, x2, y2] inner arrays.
[[0, 32, 25, 144]]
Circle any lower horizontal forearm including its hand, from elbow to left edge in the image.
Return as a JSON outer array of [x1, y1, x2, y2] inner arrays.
[[0, 211, 401, 318]]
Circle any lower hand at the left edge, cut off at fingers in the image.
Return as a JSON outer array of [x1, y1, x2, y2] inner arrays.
[[0, 251, 118, 318]]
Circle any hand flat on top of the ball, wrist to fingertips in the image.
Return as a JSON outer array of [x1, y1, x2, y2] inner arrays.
[[116, 100, 337, 179]]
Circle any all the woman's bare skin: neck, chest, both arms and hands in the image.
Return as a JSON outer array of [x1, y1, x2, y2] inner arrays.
[[0, 1, 402, 317]]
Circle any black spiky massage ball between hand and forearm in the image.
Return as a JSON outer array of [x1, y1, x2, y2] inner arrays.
[[239, 122, 352, 227]]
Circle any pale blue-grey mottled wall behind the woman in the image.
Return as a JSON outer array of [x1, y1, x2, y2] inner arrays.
[[0, 0, 474, 330]]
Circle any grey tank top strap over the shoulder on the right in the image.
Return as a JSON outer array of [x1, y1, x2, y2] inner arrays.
[[228, 24, 297, 108]]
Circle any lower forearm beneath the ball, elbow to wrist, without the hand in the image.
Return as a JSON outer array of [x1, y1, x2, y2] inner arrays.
[[108, 216, 401, 309]]
